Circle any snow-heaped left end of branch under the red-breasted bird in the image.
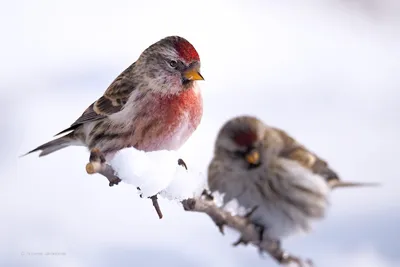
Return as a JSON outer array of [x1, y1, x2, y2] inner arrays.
[[86, 148, 204, 219]]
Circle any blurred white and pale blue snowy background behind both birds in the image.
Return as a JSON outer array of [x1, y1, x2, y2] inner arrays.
[[0, 0, 400, 267]]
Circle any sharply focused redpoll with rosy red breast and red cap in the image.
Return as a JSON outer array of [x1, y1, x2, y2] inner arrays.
[[27, 36, 203, 184]]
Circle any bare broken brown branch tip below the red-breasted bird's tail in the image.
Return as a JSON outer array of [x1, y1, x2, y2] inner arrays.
[[86, 148, 121, 186]]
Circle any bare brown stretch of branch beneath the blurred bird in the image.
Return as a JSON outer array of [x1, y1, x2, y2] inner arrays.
[[182, 197, 313, 267]]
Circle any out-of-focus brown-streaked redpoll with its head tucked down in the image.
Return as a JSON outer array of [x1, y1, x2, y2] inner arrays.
[[208, 116, 378, 241]]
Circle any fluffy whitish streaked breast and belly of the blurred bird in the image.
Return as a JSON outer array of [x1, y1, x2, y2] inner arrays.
[[208, 156, 329, 240]]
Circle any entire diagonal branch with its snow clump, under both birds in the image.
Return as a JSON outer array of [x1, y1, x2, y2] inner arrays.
[[86, 148, 312, 267]]
